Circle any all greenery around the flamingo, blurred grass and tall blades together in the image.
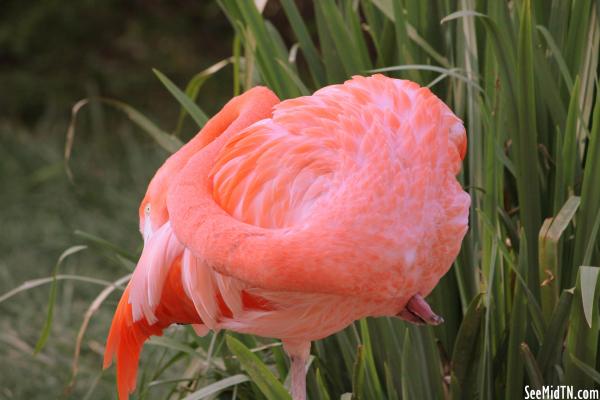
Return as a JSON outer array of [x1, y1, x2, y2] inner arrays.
[[0, 0, 600, 399]]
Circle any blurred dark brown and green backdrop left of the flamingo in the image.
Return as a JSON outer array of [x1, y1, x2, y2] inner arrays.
[[0, 0, 268, 399]]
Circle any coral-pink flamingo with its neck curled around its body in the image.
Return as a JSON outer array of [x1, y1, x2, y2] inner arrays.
[[104, 75, 470, 400]]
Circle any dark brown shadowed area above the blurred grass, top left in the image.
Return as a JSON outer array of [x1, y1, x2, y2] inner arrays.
[[0, 0, 238, 123]]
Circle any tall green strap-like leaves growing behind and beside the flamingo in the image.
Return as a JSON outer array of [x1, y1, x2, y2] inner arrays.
[[1, 0, 600, 400]]
